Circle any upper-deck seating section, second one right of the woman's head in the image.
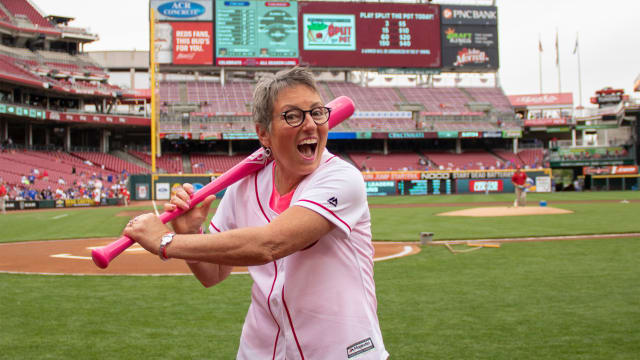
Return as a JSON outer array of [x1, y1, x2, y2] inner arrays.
[[398, 87, 472, 113]]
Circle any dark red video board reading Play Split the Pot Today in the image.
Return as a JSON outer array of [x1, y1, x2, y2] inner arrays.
[[298, 2, 440, 68]]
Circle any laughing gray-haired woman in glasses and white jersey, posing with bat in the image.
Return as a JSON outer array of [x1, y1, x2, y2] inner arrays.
[[124, 68, 388, 359]]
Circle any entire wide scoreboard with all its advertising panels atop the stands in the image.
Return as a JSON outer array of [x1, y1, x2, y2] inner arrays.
[[150, 0, 499, 73]]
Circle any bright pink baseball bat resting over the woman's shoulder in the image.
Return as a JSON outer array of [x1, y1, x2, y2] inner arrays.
[[91, 96, 355, 269]]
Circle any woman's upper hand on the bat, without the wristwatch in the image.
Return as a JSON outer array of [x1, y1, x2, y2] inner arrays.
[[164, 183, 216, 234]]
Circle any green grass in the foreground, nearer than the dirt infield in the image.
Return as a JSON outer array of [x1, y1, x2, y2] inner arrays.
[[0, 239, 640, 360]]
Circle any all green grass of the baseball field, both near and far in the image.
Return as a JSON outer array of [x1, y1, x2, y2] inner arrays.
[[0, 192, 640, 359]]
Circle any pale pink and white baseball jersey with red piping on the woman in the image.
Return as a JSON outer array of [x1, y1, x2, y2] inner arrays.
[[210, 150, 389, 360]]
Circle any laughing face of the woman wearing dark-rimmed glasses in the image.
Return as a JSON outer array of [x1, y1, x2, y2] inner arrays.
[[258, 85, 329, 180]]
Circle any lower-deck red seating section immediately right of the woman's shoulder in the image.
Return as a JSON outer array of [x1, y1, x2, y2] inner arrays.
[[348, 152, 424, 171]]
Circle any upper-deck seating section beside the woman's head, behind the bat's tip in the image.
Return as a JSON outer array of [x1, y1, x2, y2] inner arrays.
[[326, 82, 403, 111]]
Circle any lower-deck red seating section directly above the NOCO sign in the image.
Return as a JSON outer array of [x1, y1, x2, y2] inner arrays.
[[424, 150, 505, 170]]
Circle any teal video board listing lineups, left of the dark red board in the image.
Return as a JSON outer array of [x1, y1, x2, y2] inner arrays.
[[215, 0, 298, 66]]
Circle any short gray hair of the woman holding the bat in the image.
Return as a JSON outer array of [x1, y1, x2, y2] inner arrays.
[[251, 66, 320, 131]]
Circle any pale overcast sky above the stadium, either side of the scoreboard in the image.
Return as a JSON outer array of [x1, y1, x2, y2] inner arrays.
[[32, 0, 640, 106]]
